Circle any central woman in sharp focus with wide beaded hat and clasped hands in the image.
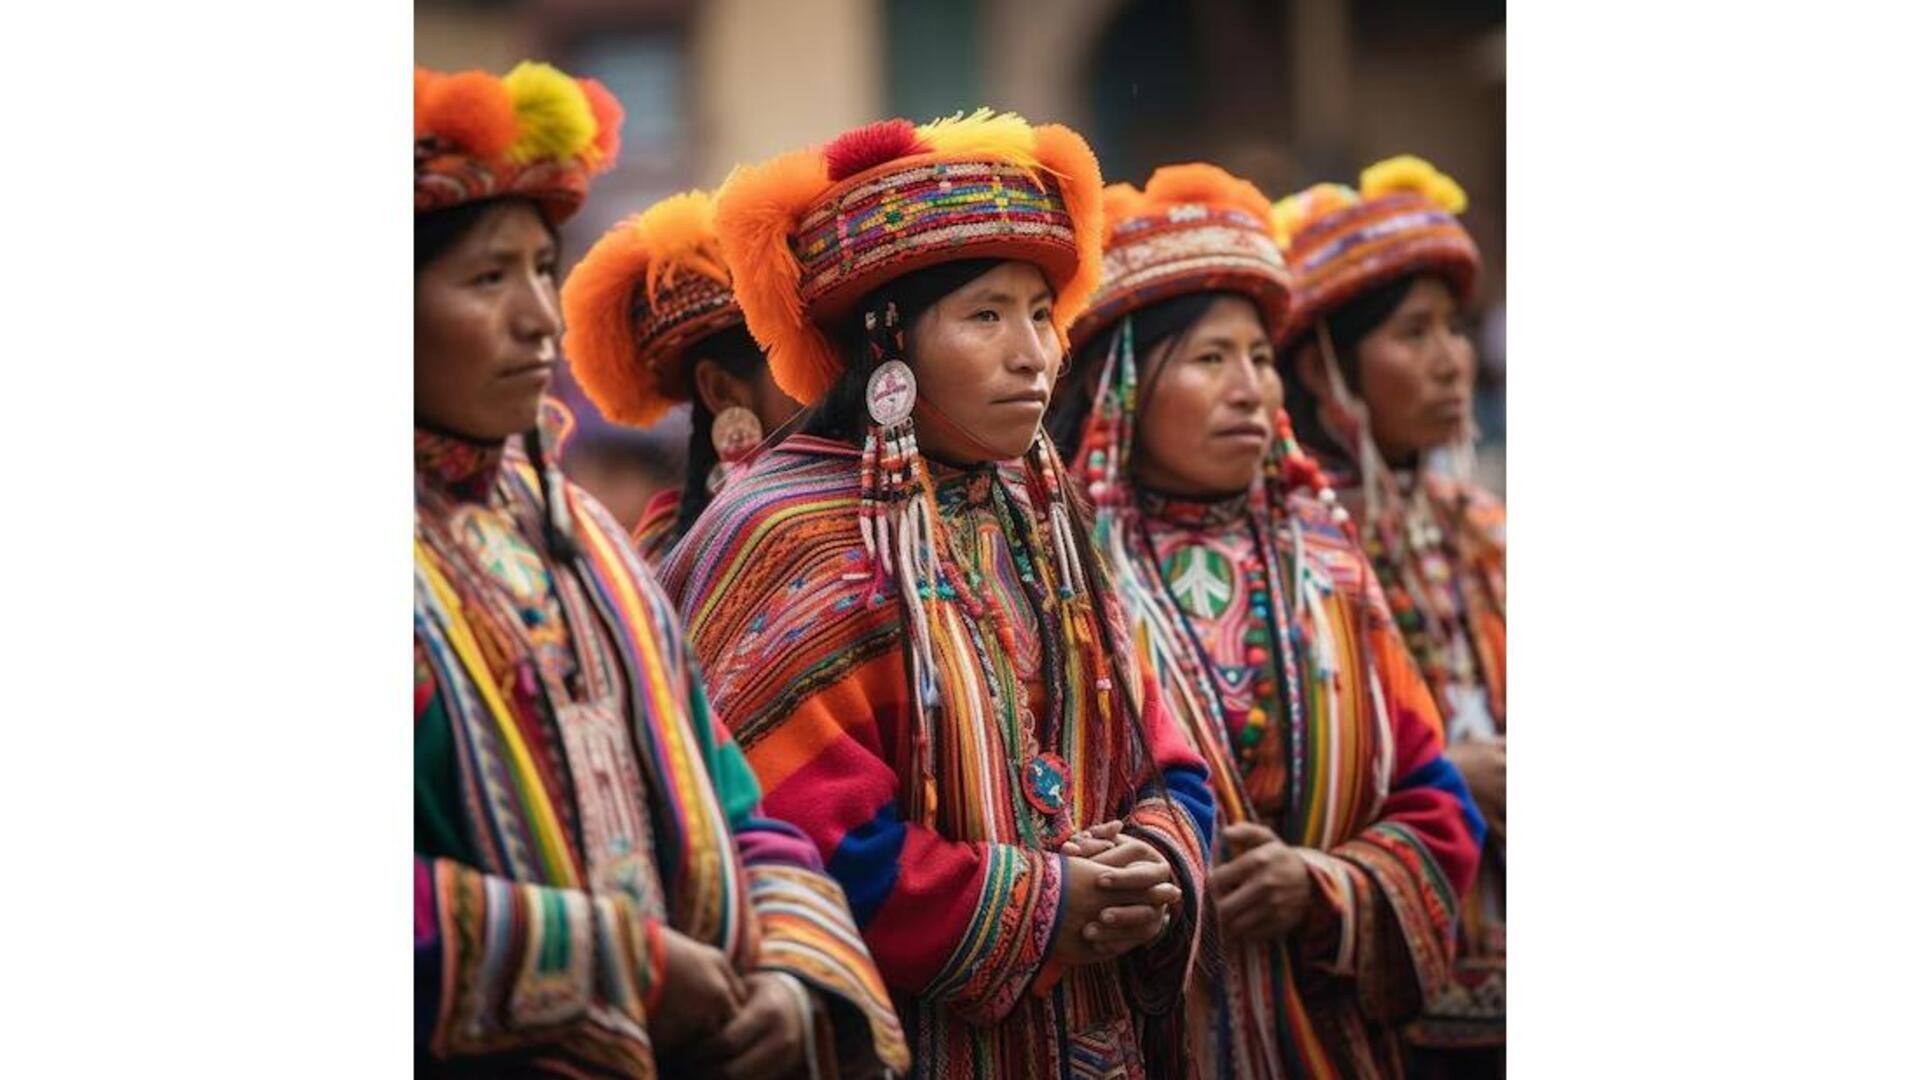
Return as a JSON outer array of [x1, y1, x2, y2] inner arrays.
[[662, 111, 1213, 1078]]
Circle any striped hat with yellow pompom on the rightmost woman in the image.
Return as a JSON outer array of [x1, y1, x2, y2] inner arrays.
[[1273, 154, 1480, 336]]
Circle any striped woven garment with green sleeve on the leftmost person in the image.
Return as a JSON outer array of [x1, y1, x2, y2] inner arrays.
[[415, 409, 908, 1076]]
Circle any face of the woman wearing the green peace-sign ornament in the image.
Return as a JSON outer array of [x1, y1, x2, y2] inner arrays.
[[1133, 296, 1283, 498]]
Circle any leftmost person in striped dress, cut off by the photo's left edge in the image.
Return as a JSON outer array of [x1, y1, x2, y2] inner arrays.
[[413, 63, 906, 1076]]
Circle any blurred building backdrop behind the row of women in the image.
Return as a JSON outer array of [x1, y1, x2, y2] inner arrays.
[[415, 0, 1507, 523]]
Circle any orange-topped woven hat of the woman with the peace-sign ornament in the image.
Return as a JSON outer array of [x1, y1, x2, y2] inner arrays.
[[1073, 163, 1292, 346]]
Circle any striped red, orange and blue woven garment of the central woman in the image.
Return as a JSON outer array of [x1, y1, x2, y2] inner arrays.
[[662, 436, 1213, 1076]]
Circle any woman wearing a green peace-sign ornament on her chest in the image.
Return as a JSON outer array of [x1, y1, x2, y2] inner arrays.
[[1052, 163, 1480, 1078]]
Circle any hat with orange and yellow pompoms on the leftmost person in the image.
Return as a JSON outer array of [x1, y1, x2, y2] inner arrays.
[[413, 61, 624, 223]]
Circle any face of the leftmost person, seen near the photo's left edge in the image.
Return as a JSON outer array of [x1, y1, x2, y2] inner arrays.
[[413, 202, 561, 442]]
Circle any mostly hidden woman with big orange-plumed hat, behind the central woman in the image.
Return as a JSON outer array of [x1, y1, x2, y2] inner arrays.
[[561, 190, 801, 565]]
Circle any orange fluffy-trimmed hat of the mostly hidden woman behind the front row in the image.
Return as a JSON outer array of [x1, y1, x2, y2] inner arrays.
[[561, 190, 743, 427]]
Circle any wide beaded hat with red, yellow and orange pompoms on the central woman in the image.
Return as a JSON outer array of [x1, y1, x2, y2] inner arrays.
[[714, 110, 1100, 404]]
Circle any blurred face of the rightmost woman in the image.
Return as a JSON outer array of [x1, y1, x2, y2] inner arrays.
[[1356, 277, 1475, 461]]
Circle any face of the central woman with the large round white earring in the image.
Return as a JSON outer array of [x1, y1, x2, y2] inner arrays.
[[906, 261, 1064, 465]]
